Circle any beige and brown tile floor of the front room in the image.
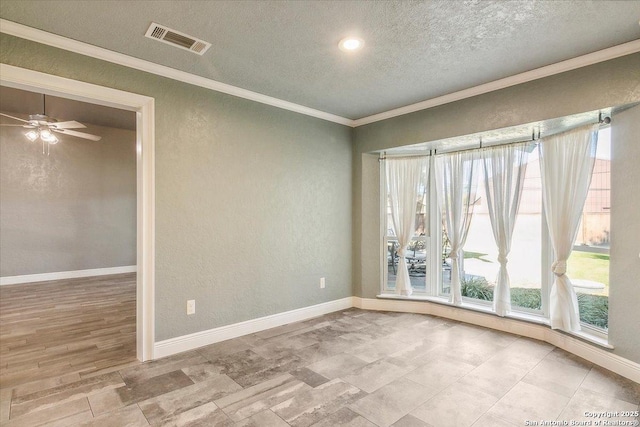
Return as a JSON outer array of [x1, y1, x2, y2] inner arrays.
[[0, 309, 640, 427]]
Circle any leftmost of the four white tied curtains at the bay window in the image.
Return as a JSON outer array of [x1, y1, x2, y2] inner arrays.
[[386, 157, 429, 296]]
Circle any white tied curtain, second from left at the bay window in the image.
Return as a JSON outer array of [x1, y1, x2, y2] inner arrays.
[[436, 150, 478, 305]]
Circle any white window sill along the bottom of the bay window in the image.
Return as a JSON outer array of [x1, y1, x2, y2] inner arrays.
[[376, 293, 614, 350]]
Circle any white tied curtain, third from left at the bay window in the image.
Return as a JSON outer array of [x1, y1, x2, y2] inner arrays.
[[482, 144, 528, 316]]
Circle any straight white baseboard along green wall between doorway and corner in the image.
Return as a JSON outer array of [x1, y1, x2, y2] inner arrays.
[[153, 297, 353, 359]]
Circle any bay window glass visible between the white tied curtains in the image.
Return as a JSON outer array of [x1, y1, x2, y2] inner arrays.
[[382, 120, 611, 338]]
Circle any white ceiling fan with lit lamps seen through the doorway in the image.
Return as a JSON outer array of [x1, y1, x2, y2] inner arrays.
[[0, 94, 102, 150]]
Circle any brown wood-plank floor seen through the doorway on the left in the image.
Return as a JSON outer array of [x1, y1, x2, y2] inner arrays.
[[0, 273, 136, 389]]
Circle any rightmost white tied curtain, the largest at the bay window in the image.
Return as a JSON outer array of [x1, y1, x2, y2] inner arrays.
[[539, 125, 598, 331]]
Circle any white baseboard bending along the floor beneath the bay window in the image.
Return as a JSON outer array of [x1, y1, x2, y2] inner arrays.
[[353, 297, 640, 383]]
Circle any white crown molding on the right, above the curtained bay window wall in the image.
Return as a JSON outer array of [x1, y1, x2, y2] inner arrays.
[[353, 39, 640, 127]]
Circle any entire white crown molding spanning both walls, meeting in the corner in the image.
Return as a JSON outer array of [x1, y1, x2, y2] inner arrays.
[[0, 19, 640, 127]]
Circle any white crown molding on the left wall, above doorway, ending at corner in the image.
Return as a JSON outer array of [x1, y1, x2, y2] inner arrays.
[[0, 19, 353, 126]]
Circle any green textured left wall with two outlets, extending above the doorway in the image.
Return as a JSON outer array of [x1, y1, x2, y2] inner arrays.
[[0, 34, 352, 340]]
